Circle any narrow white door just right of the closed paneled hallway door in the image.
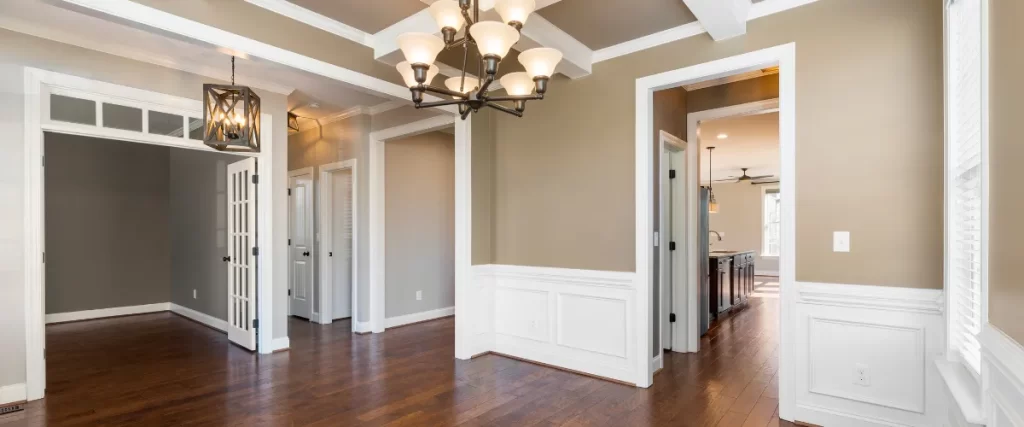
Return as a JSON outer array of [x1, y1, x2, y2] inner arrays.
[[330, 170, 352, 319]]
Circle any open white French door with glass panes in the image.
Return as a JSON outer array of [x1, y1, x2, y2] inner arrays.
[[227, 159, 257, 350]]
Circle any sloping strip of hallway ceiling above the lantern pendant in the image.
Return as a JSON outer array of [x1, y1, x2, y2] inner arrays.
[[0, 0, 395, 118]]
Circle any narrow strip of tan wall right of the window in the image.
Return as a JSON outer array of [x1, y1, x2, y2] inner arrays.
[[988, 0, 1024, 342]]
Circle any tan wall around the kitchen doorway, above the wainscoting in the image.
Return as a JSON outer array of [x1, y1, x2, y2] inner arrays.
[[495, 0, 943, 288]]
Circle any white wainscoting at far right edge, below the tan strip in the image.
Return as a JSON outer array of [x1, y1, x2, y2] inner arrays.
[[981, 325, 1024, 427]]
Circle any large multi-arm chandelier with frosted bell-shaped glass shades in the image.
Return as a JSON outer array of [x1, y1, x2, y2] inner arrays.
[[397, 0, 562, 119]]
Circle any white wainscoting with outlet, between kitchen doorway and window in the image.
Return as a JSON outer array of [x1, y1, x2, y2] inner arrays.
[[786, 283, 946, 427]]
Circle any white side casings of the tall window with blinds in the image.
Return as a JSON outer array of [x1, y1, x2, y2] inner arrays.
[[943, 0, 990, 376]]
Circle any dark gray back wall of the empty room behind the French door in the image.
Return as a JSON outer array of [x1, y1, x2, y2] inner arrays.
[[44, 133, 171, 313]]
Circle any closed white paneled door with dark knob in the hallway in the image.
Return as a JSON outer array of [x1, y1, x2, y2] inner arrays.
[[288, 173, 314, 318]]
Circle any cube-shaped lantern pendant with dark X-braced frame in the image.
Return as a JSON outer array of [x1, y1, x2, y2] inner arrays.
[[203, 56, 260, 153]]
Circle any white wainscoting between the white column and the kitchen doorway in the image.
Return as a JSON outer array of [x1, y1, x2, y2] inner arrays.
[[473, 265, 637, 383]]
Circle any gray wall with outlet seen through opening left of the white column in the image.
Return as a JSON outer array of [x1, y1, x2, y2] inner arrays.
[[384, 132, 455, 317]]
